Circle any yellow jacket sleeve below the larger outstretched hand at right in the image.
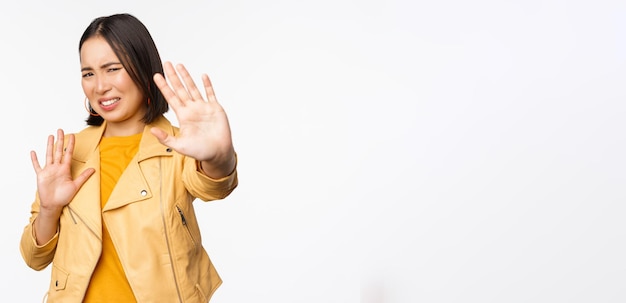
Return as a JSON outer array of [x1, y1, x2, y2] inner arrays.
[[182, 155, 238, 202]]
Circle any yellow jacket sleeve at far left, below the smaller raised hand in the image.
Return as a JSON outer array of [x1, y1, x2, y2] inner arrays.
[[20, 197, 59, 270]]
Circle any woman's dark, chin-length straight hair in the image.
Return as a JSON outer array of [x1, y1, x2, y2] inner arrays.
[[78, 14, 169, 125]]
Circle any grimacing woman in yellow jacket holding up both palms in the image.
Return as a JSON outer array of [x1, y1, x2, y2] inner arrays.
[[20, 14, 237, 303]]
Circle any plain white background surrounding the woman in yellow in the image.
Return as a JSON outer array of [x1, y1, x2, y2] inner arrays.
[[0, 0, 626, 303]]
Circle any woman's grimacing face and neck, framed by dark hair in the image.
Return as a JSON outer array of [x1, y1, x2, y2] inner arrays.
[[80, 36, 146, 133]]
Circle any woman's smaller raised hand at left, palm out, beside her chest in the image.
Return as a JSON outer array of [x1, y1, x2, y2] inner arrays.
[[30, 129, 95, 218]]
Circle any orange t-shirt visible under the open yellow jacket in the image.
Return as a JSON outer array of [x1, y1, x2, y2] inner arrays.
[[83, 133, 142, 303]]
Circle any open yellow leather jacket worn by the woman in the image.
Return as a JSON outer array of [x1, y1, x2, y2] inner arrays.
[[20, 117, 238, 303]]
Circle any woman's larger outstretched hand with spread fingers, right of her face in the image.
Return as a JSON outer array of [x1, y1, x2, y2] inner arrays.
[[151, 62, 235, 178]]
